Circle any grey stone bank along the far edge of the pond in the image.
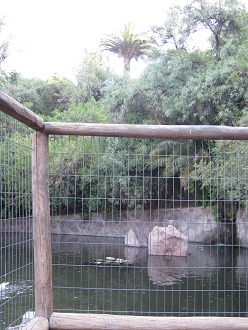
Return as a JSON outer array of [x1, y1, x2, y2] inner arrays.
[[1, 207, 248, 247]]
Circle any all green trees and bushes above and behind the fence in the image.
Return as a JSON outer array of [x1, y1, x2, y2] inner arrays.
[[0, 0, 248, 219]]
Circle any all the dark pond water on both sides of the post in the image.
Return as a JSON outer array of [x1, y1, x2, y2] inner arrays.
[[0, 236, 248, 329]]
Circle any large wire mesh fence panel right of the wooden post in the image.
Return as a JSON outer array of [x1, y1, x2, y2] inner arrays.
[[50, 136, 248, 316]]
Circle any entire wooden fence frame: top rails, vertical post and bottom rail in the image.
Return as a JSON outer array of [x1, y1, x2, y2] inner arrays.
[[0, 91, 248, 330]]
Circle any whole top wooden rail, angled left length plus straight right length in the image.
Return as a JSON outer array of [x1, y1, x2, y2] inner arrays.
[[0, 87, 248, 140]]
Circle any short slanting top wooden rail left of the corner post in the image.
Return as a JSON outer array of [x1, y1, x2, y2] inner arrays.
[[0, 91, 44, 131]]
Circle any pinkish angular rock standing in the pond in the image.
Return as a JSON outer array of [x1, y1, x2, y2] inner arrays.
[[148, 225, 189, 257]]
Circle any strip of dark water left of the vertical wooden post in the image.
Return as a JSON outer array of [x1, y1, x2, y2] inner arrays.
[[0, 234, 34, 330]]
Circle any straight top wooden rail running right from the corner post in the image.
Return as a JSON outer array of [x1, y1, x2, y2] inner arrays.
[[43, 122, 248, 140]]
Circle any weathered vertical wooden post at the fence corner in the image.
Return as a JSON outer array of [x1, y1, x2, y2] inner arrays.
[[32, 132, 53, 319]]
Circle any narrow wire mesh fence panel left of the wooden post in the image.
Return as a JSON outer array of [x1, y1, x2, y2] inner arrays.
[[0, 112, 33, 329]]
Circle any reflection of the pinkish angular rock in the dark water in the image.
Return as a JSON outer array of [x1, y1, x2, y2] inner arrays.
[[148, 255, 188, 285]]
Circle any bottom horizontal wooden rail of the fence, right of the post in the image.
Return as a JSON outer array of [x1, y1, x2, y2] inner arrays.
[[49, 313, 248, 330]]
